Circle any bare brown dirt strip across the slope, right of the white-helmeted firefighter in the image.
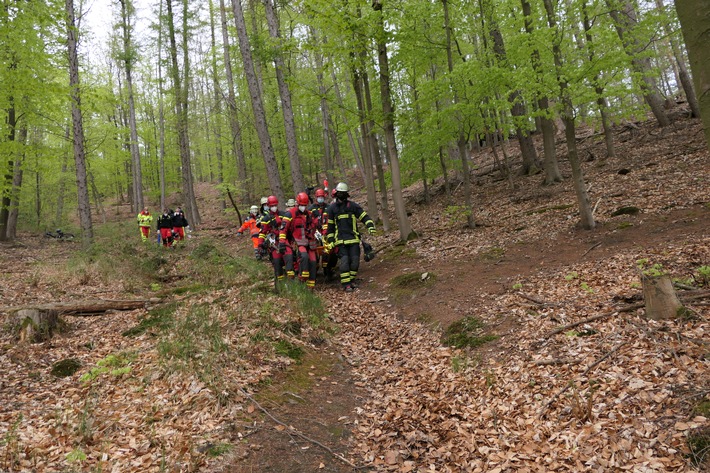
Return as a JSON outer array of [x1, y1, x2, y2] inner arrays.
[[361, 205, 710, 327]]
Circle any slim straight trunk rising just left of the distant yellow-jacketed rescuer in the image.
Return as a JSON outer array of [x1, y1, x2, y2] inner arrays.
[[119, 0, 143, 213]]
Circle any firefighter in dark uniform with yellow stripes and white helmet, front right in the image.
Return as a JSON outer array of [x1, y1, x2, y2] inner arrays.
[[325, 182, 376, 292]]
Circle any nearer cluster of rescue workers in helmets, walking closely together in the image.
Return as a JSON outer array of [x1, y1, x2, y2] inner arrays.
[[237, 182, 376, 292]]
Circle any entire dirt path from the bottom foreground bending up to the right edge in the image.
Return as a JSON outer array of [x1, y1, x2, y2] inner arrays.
[[229, 201, 710, 473]]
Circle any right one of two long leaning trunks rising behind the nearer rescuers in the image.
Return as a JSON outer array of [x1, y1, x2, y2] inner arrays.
[[263, 0, 306, 194]]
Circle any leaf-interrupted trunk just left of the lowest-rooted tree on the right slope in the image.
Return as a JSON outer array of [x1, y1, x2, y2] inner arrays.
[[521, 0, 562, 185]]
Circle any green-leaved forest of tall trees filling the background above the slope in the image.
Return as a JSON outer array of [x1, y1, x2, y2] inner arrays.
[[0, 0, 708, 245]]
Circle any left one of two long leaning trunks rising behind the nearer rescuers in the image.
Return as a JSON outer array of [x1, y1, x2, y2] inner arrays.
[[232, 0, 284, 202]]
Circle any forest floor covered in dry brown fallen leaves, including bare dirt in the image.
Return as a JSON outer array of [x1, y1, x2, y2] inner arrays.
[[0, 104, 710, 473]]
